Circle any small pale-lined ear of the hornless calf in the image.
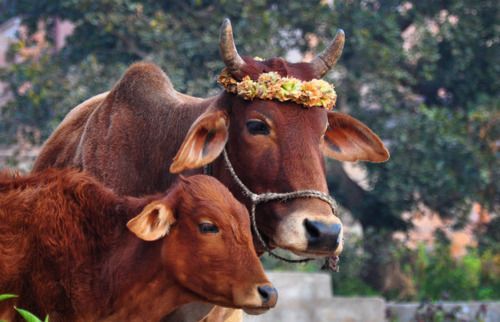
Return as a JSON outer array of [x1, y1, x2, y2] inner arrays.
[[127, 201, 175, 241]]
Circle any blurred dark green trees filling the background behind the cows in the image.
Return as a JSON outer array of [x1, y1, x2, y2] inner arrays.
[[0, 0, 500, 294]]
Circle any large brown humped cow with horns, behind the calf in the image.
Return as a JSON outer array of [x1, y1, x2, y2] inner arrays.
[[34, 19, 389, 320]]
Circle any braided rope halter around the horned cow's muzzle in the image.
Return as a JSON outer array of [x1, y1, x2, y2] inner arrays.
[[223, 149, 337, 263]]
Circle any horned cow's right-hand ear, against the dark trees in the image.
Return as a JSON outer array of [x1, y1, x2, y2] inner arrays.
[[323, 112, 389, 162]]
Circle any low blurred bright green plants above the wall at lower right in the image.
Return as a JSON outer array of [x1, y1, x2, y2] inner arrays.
[[332, 235, 500, 301]]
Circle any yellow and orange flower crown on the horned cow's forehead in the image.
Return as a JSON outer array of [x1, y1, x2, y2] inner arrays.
[[218, 68, 337, 110]]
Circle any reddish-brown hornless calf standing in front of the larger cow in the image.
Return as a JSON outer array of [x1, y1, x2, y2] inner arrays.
[[0, 169, 277, 322]]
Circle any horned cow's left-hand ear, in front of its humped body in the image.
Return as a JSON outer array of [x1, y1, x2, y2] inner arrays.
[[170, 110, 229, 173]]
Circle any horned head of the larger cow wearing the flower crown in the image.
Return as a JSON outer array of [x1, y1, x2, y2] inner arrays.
[[170, 20, 389, 256]]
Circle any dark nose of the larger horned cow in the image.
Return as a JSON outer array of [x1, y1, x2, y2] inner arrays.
[[304, 218, 342, 252]]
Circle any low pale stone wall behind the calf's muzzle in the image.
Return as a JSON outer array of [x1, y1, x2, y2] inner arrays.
[[243, 272, 500, 322]]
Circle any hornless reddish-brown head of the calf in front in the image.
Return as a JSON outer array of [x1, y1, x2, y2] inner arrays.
[[127, 175, 277, 313]]
